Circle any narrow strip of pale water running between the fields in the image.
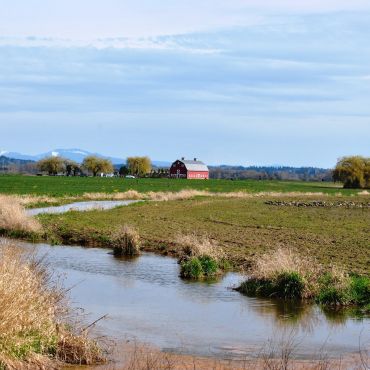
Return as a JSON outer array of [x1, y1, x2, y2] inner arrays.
[[27, 200, 140, 216]]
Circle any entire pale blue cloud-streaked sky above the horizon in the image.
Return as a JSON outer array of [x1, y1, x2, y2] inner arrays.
[[0, 0, 370, 167]]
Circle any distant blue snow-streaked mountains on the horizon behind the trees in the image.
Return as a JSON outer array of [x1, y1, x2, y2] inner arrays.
[[0, 148, 171, 167]]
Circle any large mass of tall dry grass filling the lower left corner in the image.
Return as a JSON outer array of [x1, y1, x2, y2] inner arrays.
[[0, 242, 103, 369]]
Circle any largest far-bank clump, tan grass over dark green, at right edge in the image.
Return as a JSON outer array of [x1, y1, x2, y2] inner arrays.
[[237, 248, 370, 310]]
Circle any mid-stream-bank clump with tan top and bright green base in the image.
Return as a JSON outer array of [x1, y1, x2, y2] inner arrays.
[[177, 235, 228, 279]]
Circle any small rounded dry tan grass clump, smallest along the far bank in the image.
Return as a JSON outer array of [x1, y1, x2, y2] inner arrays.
[[112, 225, 140, 257]]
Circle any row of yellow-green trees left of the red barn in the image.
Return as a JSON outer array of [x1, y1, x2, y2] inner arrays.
[[36, 155, 152, 177]]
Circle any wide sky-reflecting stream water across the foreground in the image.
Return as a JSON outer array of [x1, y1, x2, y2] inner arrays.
[[8, 240, 370, 356]]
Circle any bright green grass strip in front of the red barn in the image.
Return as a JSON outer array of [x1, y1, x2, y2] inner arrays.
[[0, 175, 358, 197]]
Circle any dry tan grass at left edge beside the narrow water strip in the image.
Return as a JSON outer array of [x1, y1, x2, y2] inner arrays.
[[0, 195, 41, 232]]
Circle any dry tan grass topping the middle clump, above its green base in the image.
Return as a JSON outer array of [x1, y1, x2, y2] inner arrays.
[[175, 234, 225, 261]]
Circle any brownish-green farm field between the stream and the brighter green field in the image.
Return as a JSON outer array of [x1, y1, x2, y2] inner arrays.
[[39, 196, 370, 274]]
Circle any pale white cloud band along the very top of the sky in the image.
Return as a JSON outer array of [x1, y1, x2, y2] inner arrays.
[[0, 0, 370, 41]]
